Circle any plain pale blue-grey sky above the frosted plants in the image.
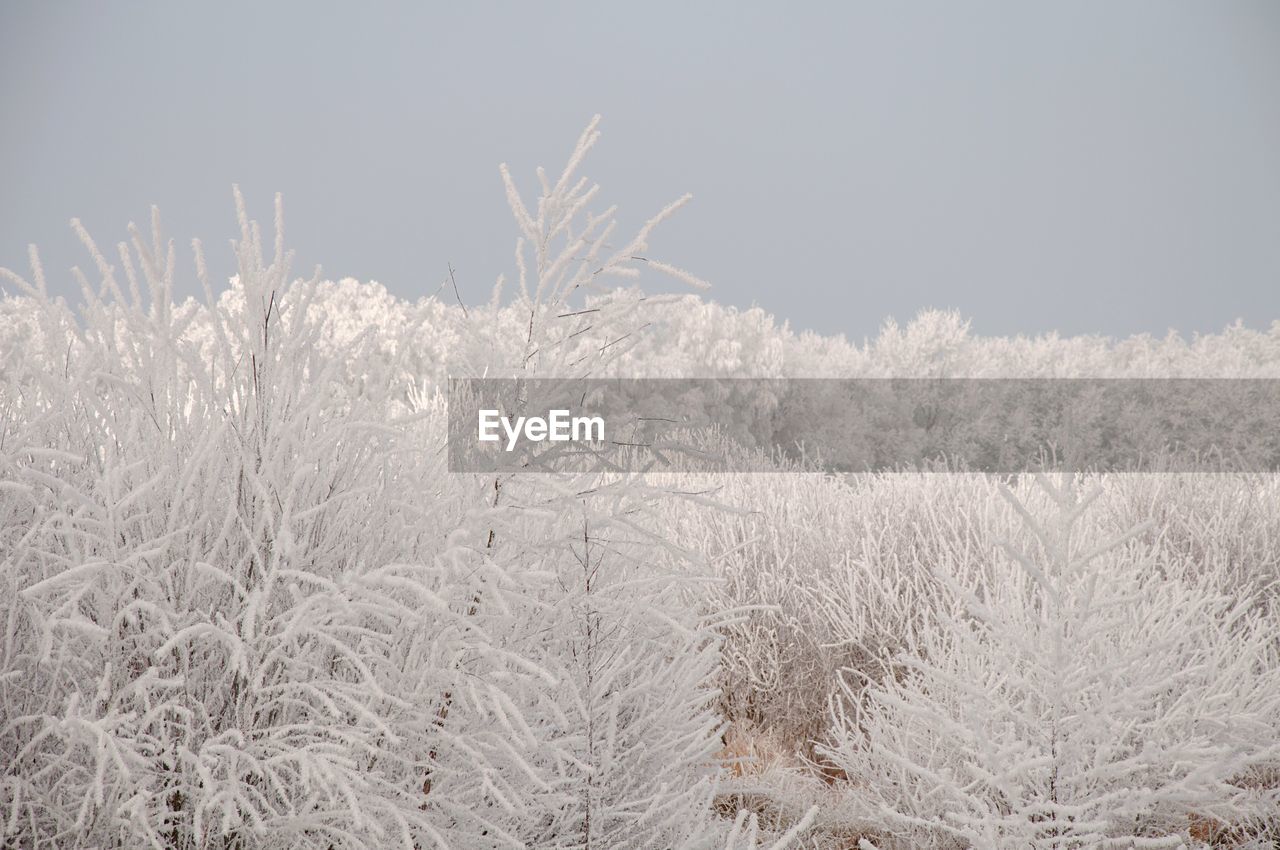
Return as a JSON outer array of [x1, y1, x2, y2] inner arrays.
[[0, 0, 1280, 338]]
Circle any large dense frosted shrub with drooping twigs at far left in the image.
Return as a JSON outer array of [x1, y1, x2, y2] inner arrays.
[[0, 198, 473, 847]]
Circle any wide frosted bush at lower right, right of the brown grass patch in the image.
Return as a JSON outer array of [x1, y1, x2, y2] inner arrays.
[[827, 480, 1280, 849]]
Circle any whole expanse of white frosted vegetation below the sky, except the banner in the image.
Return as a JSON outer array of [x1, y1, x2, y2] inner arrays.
[[0, 123, 1280, 850]]
